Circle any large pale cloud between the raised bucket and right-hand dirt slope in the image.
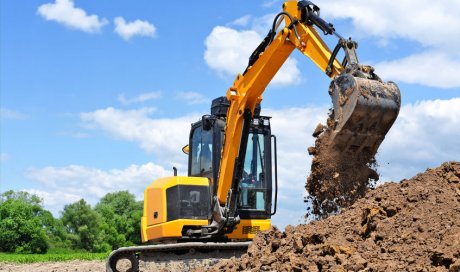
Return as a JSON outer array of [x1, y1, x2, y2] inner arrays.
[[378, 98, 460, 181]]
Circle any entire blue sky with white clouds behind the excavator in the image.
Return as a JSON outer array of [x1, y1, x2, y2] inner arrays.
[[0, 0, 460, 228]]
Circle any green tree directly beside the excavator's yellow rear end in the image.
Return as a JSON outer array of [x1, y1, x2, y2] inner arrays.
[[95, 191, 143, 249]]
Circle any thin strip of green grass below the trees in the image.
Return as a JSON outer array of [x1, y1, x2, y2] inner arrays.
[[0, 252, 109, 264]]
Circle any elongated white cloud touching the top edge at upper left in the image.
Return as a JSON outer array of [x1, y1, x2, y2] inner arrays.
[[38, 0, 108, 33]]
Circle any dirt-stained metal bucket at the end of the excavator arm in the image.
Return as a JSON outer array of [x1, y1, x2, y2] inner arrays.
[[328, 73, 401, 156]]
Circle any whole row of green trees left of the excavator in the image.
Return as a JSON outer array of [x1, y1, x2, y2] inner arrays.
[[0, 191, 143, 254]]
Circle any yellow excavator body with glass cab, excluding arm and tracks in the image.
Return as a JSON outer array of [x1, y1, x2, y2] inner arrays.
[[141, 97, 277, 242]]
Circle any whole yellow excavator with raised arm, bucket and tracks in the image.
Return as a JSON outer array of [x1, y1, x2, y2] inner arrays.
[[106, 0, 400, 271]]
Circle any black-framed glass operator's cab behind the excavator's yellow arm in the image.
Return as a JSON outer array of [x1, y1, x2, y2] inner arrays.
[[187, 97, 276, 226]]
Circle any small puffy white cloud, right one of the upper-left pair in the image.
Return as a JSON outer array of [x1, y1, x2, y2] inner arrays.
[[113, 17, 156, 40]]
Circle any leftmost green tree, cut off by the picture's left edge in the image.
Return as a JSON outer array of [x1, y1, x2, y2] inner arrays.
[[0, 190, 52, 253]]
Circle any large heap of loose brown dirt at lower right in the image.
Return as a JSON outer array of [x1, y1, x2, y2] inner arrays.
[[212, 162, 460, 271]]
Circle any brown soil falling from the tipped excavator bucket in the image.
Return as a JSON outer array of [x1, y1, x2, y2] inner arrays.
[[305, 113, 379, 219]]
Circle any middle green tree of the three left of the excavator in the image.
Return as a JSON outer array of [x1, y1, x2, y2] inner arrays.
[[61, 199, 101, 251]]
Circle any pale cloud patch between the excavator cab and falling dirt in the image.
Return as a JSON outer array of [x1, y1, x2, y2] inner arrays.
[[263, 106, 328, 228]]
